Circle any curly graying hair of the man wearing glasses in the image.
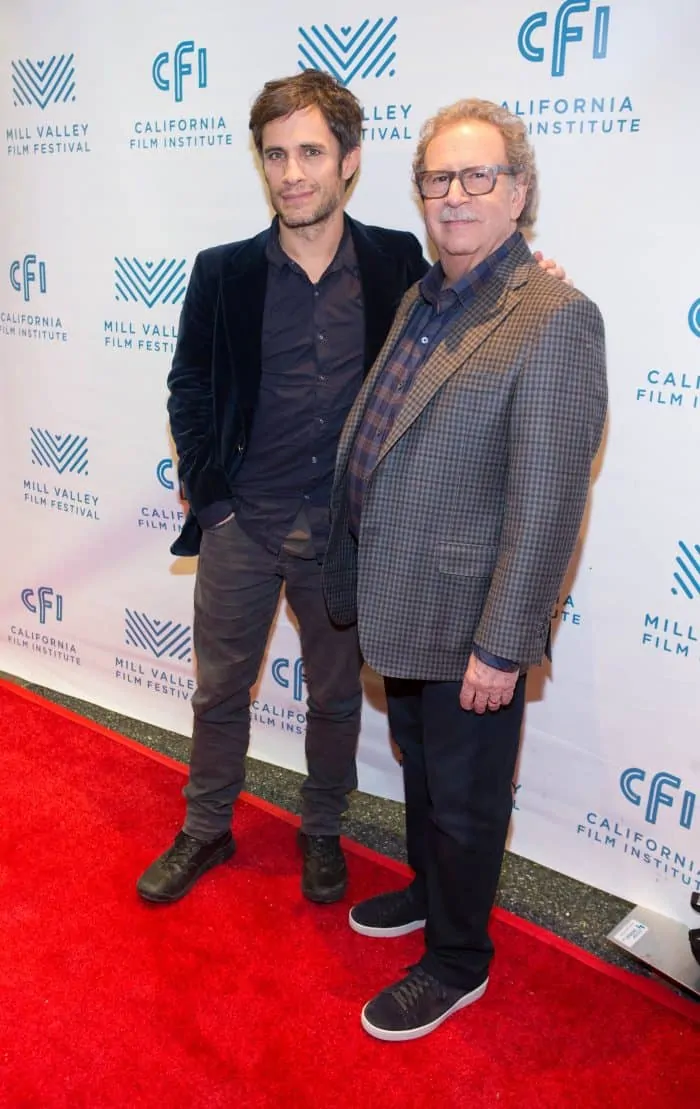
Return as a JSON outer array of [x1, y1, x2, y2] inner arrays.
[[413, 99, 539, 227]]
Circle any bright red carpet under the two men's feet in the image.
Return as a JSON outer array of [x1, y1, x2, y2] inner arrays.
[[0, 683, 700, 1109]]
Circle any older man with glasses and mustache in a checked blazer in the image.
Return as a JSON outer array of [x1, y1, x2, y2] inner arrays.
[[324, 100, 607, 1040]]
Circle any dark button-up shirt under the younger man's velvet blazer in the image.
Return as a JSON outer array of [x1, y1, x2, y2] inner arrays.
[[233, 221, 365, 555]]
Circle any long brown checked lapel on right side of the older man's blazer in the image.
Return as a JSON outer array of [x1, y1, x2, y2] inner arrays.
[[375, 247, 529, 466]]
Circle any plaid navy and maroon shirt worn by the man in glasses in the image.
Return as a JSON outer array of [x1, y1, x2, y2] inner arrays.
[[347, 231, 520, 670]]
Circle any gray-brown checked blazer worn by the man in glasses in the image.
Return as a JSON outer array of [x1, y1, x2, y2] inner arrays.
[[324, 242, 607, 681]]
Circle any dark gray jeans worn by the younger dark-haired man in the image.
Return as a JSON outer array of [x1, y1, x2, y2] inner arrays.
[[184, 518, 362, 840]]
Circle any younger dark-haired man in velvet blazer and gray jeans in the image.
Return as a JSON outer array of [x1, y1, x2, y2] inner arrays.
[[138, 70, 567, 902]]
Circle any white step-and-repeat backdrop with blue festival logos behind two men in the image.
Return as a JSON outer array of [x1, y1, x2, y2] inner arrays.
[[0, 0, 700, 920]]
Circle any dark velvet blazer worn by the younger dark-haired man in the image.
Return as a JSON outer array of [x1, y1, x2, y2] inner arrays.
[[168, 216, 427, 555]]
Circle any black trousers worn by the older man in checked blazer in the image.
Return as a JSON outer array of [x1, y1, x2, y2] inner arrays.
[[385, 676, 525, 989]]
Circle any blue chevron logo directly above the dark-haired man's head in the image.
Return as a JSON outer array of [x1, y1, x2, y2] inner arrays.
[[297, 16, 397, 85]]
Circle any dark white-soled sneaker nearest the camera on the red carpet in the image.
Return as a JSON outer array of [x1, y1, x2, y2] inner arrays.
[[362, 966, 488, 1041]]
